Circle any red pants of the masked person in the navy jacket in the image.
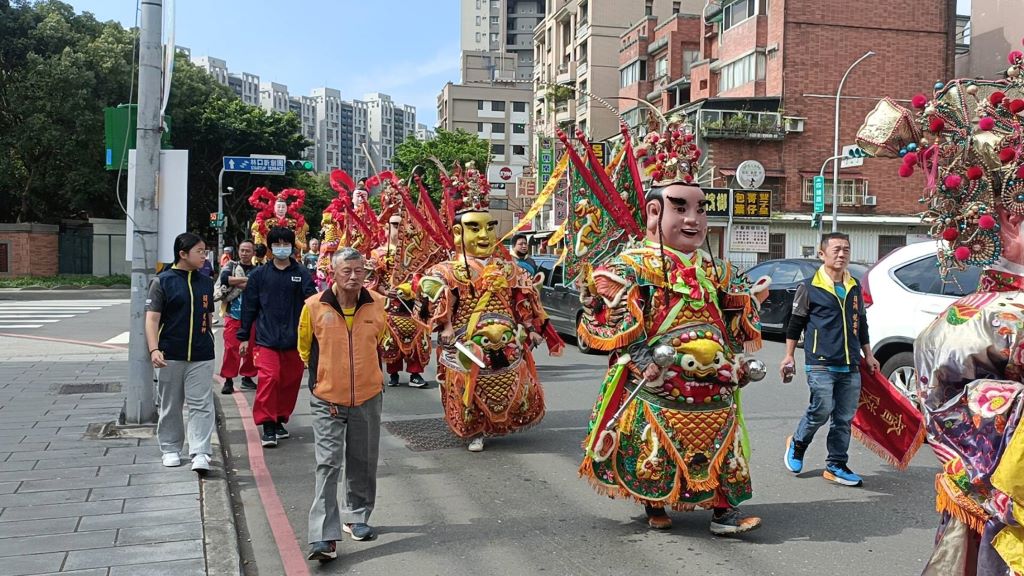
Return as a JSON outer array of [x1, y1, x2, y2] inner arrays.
[[253, 345, 304, 425]]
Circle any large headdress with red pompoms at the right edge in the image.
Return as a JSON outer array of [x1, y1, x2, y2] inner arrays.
[[857, 44, 1024, 271]]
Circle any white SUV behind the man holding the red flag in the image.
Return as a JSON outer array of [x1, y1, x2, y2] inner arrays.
[[861, 242, 981, 400]]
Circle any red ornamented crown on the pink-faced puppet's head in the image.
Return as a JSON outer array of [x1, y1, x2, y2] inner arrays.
[[636, 119, 700, 188]]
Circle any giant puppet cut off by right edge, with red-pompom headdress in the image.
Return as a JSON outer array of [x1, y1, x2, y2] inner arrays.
[[857, 41, 1024, 576]]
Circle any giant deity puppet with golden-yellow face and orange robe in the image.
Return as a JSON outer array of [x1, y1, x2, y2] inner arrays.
[[418, 162, 564, 452]]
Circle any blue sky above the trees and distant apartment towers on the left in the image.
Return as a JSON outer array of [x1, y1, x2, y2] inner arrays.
[[66, 0, 459, 126]]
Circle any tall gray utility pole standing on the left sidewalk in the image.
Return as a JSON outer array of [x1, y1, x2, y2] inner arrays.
[[125, 0, 164, 424]]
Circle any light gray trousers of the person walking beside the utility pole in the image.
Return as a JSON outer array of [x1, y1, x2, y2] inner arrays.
[[157, 360, 217, 456]]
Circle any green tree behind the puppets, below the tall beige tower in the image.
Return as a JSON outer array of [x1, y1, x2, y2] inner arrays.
[[394, 129, 490, 205]]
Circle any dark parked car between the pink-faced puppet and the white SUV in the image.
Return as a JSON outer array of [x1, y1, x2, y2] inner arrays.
[[745, 258, 867, 336]]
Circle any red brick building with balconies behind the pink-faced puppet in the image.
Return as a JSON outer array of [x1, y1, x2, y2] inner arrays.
[[620, 0, 955, 265]]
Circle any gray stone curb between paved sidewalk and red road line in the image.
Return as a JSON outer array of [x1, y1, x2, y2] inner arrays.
[[200, 390, 242, 576]]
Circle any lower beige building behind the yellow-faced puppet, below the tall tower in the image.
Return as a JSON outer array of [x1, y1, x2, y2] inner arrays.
[[437, 82, 532, 231]]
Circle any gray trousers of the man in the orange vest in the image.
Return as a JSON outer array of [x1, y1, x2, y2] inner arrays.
[[309, 393, 383, 544]]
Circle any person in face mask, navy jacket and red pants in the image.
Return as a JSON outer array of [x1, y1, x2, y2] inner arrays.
[[236, 228, 316, 448]]
